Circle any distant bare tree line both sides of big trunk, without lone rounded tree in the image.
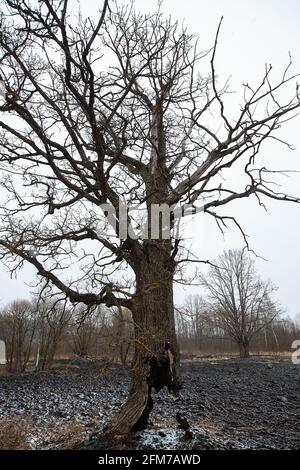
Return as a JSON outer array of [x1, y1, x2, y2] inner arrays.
[[0, 295, 300, 372]]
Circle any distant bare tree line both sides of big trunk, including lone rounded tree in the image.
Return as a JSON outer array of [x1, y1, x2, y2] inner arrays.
[[0, 250, 300, 372]]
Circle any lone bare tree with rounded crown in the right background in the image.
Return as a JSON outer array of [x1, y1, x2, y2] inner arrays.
[[201, 250, 281, 357]]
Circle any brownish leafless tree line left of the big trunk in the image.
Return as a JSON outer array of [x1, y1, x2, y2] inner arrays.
[[0, 299, 133, 372]]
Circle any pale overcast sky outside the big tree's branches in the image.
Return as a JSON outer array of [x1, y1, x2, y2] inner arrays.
[[0, 0, 300, 316]]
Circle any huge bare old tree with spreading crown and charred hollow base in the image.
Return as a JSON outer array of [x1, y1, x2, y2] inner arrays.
[[0, 0, 299, 434]]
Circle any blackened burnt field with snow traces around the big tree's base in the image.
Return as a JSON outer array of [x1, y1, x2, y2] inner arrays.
[[0, 357, 300, 450]]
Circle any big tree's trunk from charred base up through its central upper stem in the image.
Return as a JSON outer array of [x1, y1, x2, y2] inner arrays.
[[103, 101, 180, 436]]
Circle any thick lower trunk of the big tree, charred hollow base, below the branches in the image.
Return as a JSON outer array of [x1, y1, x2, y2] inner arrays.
[[108, 240, 180, 436]]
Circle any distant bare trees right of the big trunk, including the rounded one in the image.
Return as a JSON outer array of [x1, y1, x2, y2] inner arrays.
[[177, 250, 300, 357]]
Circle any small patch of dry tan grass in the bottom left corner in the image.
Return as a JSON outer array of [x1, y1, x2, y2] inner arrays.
[[0, 417, 32, 450]]
